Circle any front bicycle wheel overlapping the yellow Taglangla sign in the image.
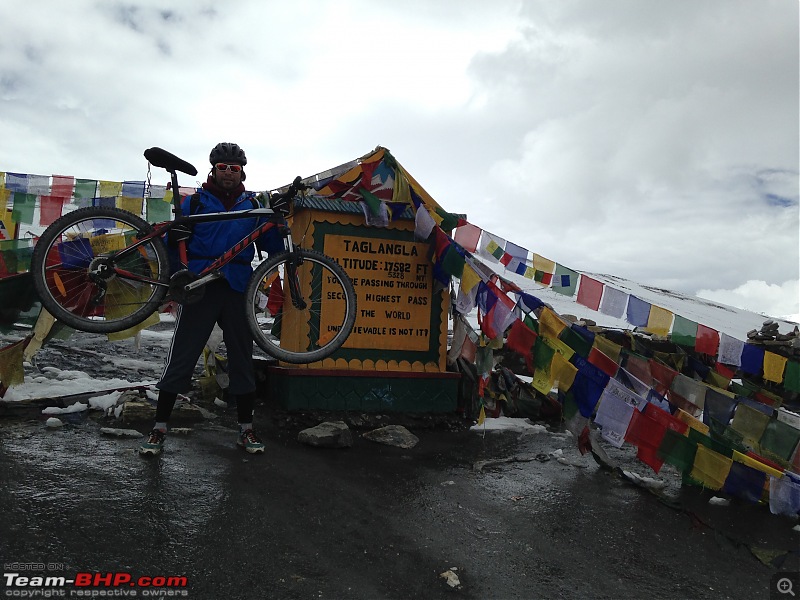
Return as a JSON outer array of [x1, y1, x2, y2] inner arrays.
[[245, 249, 356, 364]]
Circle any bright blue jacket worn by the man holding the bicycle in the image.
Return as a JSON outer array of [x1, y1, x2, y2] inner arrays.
[[176, 189, 277, 292]]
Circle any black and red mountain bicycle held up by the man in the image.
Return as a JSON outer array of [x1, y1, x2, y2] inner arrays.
[[31, 147, 356, 364]]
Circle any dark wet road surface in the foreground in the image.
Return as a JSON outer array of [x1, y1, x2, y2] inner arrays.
[[0, 412, 800, 600]]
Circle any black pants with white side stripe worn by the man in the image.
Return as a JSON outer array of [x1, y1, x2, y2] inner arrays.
[[156, 279, 256, 422]]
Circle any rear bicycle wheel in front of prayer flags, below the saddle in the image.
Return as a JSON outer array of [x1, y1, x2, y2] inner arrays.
[[31, 207, 170, 333]]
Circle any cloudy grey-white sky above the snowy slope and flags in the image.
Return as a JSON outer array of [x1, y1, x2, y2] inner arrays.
[[0, 0, 800, 316]]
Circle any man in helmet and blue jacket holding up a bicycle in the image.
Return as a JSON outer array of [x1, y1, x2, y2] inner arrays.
[[139, 142, 264, 454]]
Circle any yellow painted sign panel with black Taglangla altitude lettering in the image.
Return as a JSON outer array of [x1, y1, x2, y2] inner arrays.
[[321, 234, 438, 351]]
